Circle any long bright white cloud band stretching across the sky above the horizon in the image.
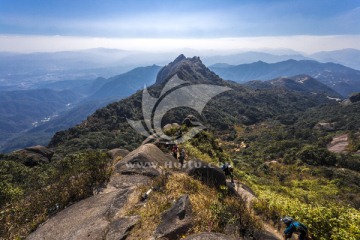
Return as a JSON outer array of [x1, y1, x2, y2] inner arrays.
[[0, 35, 360, 53]]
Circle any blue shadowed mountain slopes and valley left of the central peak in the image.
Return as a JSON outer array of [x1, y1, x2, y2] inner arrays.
[[0, 65, 160, 152]]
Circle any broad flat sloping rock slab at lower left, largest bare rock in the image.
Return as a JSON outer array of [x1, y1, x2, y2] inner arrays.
[[27, 188, 138, 240]]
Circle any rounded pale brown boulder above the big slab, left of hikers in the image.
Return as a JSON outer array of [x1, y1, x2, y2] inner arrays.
[[115, 143, 175, 177]]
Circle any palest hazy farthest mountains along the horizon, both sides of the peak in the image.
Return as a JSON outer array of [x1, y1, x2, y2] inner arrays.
[[0, 48, 360, 91]]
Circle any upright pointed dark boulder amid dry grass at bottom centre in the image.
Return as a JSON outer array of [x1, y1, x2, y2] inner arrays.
[[155, 195, 192, 239]]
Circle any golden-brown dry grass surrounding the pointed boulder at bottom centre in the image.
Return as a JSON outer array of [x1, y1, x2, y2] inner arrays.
[[128, 173, 256, 239]]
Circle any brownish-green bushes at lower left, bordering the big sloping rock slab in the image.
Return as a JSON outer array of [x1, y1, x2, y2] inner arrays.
[[0, 151, 111, 239]]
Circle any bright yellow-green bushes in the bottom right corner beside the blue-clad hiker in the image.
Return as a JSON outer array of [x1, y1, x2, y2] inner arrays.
[[254, 191, 360, 240]]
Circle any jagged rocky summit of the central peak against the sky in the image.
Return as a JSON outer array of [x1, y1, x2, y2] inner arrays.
[[156, 54, 223, 84]]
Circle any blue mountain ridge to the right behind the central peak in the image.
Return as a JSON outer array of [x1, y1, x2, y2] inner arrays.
[[210, 60, 360, 97]]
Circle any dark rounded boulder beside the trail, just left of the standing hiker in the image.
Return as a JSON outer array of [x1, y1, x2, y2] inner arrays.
[[187, 160, 226, 188]]
